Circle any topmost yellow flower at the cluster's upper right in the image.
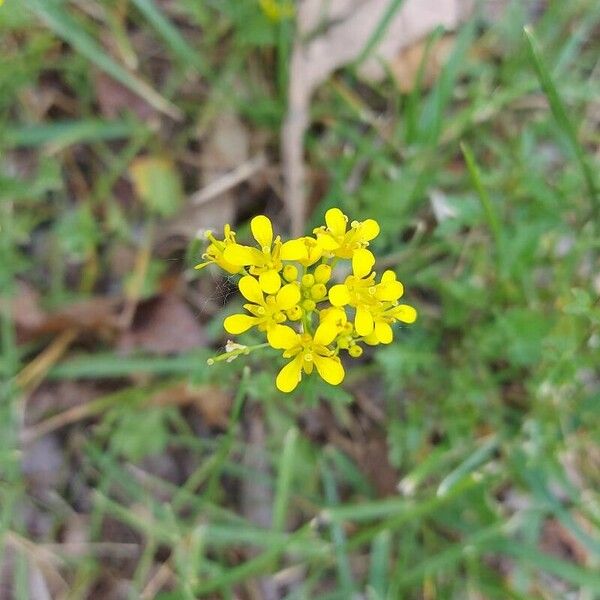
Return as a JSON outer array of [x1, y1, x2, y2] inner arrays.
[[313, 208, 379, 262]]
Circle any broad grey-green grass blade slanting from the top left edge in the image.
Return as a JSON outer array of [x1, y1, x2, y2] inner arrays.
[[25, 0, 183, 119]]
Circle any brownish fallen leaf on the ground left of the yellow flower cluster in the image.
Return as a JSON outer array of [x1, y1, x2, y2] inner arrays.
[[117, 294, 206, 354]]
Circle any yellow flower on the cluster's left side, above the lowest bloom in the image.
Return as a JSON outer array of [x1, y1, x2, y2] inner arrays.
[[223, 275, 300, 334]]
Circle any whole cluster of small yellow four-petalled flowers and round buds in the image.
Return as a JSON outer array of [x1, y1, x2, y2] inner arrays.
[[196, 208, 417, 392]]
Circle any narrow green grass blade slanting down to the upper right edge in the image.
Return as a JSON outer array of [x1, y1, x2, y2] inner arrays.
[[524, 27, 600, 216]]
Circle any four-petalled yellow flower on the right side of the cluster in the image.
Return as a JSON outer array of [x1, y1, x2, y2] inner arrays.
[[329, 262, 404, 336]]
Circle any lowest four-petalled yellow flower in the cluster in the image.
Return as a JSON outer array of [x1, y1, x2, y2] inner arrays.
[[267, 321, 345, 392]]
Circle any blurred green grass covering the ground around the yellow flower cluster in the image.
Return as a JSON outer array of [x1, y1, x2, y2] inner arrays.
[[0, 0, 600, 600]]
